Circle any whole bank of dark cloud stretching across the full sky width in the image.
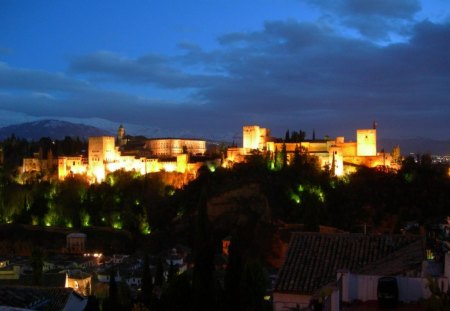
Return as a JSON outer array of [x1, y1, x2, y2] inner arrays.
[[0, 18, 450, 138]]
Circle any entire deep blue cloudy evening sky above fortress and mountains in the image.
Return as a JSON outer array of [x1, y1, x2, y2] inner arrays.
[[0, 0, 450, 139]]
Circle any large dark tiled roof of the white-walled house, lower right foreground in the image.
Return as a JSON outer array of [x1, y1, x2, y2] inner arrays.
[[275, 233, 423, 294]]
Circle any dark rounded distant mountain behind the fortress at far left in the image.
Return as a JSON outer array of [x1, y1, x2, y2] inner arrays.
[[0, 120, 112, 140]]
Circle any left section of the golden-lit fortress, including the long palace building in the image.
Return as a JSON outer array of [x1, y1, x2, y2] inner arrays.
[[22, 125, 213, 182]]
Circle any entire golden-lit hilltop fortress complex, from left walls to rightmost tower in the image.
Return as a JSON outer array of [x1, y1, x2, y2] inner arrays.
[[22, 125, 395, 182]]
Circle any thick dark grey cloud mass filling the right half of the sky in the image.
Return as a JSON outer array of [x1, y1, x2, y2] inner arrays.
[[192, 21, 450, 138]]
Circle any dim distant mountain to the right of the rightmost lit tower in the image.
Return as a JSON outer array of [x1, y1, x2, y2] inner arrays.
[[378, 137, 450, 155]]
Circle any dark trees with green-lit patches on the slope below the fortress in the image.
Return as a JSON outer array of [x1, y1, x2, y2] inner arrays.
[[0, 140, 450, 240]]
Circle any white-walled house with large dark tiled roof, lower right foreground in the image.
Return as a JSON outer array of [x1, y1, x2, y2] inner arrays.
[[273, 232, 434, 311]]
